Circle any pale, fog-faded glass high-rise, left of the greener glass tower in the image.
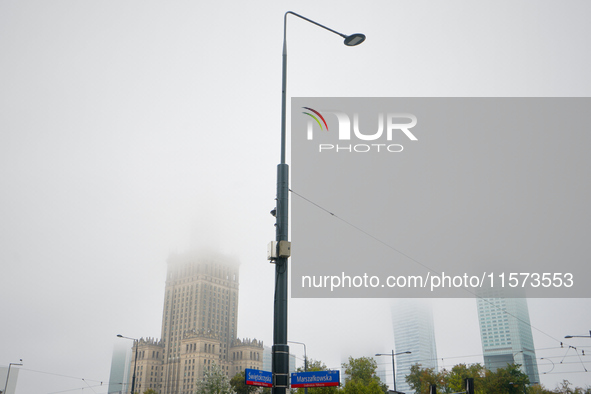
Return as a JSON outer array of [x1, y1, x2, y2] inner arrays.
[[392, 298, 437, 393]]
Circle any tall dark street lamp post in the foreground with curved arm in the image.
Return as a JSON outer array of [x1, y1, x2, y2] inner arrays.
[[271, 11, 365, 394]]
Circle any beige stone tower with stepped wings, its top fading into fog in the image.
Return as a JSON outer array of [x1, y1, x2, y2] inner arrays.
[[112, 253, 263, 394]]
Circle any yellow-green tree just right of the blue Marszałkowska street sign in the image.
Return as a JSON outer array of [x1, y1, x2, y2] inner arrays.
[[343, 357, 388, 394]]
